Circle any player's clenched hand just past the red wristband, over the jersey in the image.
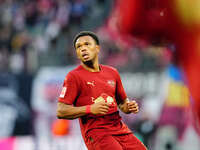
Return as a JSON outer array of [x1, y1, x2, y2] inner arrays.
[[90, 101, 109, 115]]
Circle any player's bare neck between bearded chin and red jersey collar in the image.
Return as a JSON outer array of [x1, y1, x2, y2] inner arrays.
[[81, 61, 100, 72]]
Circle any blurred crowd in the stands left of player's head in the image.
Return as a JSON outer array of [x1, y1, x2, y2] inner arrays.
[[0, 0, 112, 73]]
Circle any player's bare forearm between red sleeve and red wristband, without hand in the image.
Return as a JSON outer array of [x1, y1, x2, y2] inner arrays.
[[57, 103, 86, 119]]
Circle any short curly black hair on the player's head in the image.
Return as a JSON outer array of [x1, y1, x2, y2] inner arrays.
[[73, 31, 99, 49]]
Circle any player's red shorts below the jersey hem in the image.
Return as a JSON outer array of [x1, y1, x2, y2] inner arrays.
[[87, 134, 147, 150]]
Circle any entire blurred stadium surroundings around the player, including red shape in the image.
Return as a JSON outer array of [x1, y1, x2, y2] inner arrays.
[[0, 0, 200, 150]]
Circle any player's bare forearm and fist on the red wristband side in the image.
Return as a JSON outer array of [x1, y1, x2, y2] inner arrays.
[[57, 102, 109, 119]]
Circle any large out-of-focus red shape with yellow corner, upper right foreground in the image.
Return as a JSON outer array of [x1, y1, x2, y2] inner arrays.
[[115, 0, 200, 134]]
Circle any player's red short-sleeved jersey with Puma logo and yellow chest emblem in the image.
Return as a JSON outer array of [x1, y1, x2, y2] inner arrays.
[[59, 65, 131, 139]]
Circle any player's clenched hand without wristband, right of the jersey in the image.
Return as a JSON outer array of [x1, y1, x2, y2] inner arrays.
[[118, 98, 139, 114]]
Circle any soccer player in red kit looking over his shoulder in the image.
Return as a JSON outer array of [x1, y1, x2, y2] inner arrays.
[[57, 31, 146, 150]]
